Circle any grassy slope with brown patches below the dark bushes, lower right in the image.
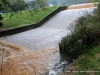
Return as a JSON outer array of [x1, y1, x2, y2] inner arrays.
[[61, 45, 100, 75]]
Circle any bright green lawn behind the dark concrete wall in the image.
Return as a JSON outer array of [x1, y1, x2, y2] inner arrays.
[[2, 6, 58, 29]]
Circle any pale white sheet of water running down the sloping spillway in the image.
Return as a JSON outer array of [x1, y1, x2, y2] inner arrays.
[[0, 8, 92, 50]]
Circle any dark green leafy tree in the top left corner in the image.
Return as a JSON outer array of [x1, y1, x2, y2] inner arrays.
[[0, 0, 27, 12]]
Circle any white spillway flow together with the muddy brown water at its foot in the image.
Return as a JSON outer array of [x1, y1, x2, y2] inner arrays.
[[0, 8, 93, 75]]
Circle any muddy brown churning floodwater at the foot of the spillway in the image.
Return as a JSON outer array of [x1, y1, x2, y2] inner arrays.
[[0, 41, 60, 75]]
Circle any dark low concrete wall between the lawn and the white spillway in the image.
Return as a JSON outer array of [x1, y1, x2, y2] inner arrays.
[[0, 6, 67, 37]]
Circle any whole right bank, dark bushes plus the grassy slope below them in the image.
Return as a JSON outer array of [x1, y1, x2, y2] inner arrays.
[[59, 4, 100, 75]]
